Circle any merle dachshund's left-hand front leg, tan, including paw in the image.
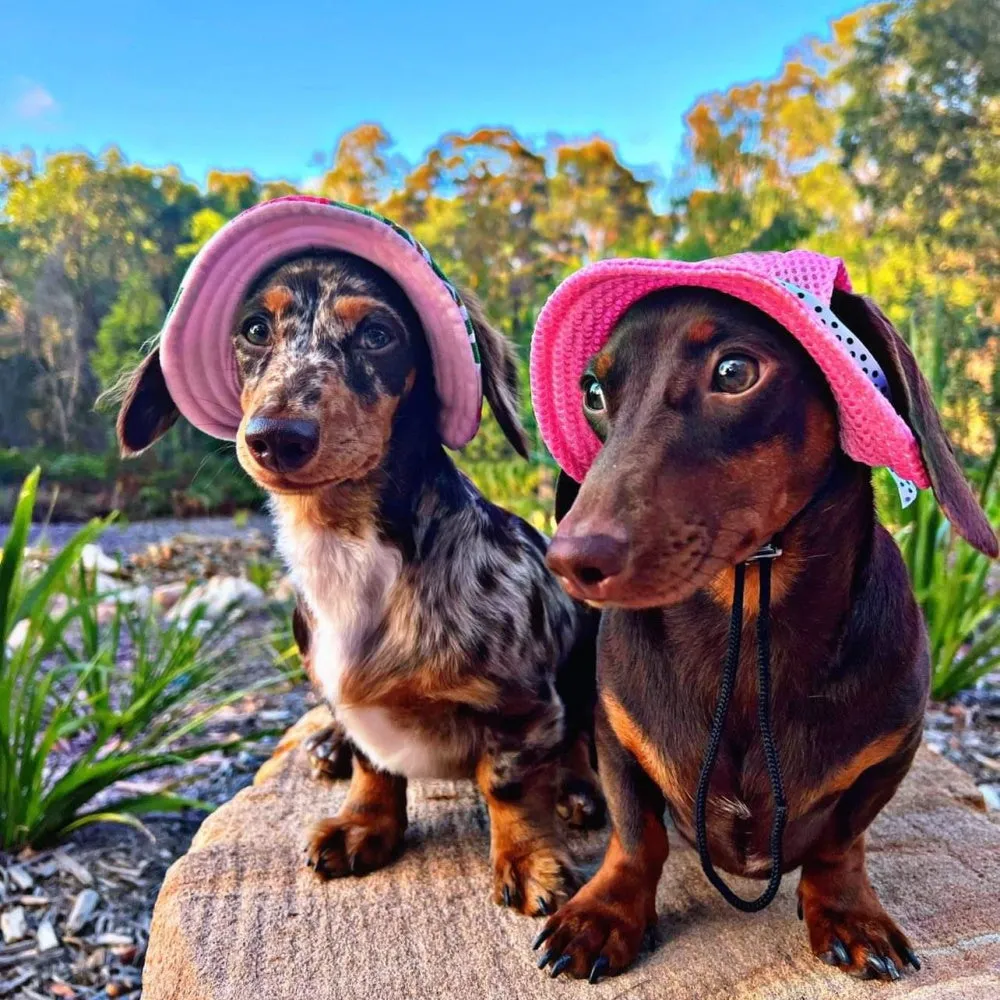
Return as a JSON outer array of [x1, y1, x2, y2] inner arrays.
[[306, 751, 406, 878]]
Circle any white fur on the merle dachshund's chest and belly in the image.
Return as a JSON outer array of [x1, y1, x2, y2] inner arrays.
[[275, 503, 441, 778]]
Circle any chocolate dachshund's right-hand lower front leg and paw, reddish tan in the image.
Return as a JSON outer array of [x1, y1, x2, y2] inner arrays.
[[799, 835, 920, 980]]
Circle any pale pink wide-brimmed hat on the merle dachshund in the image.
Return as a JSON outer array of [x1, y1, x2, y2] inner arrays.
[[160, 195, 483, 448]]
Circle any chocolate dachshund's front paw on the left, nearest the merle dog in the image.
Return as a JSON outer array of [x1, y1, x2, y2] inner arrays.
[[533, 883, 651, 983]]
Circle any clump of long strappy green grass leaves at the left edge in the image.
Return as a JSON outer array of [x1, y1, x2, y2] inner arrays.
[[0, 470, 261, 851]]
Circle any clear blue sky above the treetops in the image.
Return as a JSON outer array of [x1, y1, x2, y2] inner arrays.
[[0, 0, 858, 191]]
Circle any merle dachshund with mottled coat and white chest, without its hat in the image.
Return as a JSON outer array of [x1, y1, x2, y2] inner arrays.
[[118, 253, 603, 913]]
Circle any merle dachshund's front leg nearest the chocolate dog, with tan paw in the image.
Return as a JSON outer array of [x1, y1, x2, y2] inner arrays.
[[476, 751, 576, 916]]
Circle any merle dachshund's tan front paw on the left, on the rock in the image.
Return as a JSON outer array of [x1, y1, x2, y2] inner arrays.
[[306, 810, 405, 878]]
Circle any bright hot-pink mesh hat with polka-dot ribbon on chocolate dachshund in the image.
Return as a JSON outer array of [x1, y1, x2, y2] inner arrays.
[[531, 250, 930, 492]]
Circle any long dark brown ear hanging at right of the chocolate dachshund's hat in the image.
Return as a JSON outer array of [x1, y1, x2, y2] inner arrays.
[[832, 292, 1000, 559]]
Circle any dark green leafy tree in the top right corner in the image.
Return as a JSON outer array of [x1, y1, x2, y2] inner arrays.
[[840, 0, 1000, 304]]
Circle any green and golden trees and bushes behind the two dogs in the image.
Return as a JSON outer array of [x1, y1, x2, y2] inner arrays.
[[0, 0, 1000, 693]]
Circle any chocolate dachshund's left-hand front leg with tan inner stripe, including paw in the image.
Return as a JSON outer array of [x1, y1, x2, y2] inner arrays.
[[535, 709, 669, 982]]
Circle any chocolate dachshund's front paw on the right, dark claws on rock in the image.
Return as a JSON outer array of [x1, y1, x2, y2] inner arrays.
[[800, 894, 920, 982]]
